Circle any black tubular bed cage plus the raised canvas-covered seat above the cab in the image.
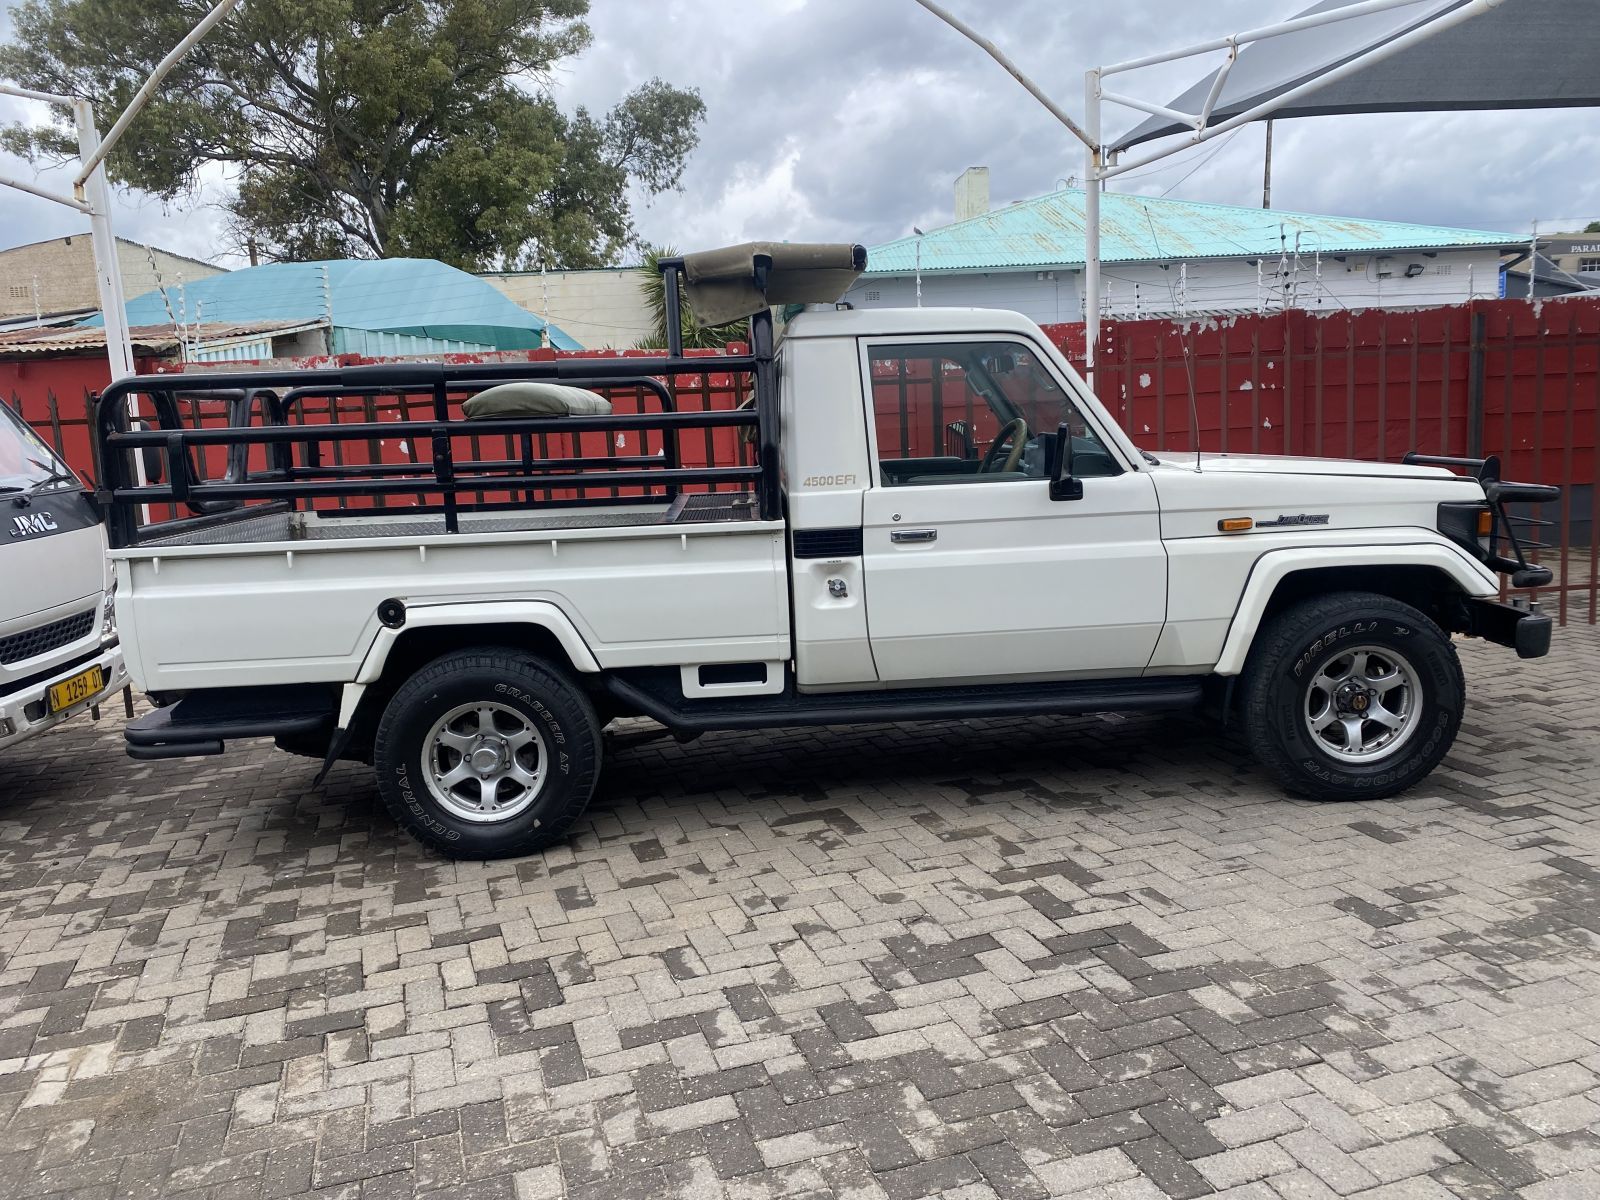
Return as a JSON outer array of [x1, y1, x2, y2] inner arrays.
[[94, 242, 867, 547]]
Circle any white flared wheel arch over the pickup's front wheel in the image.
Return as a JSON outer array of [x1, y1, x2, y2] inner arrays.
[[1216, 542, 1499, 675]]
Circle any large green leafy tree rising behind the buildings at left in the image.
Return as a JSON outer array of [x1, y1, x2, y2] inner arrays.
[[0, 0, 706, 270]]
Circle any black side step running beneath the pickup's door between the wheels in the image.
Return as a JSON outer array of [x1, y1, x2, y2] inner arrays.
[[605, 674, 1202, 734]]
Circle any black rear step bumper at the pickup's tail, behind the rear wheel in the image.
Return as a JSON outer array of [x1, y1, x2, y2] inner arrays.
[[122, 685, 336, 758]]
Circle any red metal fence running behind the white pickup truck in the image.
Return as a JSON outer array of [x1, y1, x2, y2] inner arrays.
[[10, 298, 1600, 622]]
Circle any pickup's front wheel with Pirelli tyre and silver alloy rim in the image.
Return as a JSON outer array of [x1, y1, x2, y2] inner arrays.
[[1243, 592, 1466, 800]]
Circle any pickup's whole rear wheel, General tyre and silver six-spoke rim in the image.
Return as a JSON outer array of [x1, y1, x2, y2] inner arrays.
[[373, 646, 602, 859]]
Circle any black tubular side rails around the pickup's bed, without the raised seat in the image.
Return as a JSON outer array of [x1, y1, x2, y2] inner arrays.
[[94, 361, 779, 547]]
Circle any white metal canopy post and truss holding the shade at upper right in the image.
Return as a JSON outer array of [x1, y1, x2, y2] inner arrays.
[[1083, 0, 1512, 381]]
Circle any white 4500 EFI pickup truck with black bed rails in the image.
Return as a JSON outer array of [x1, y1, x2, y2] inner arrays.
[[98, 243, 1557, 858]]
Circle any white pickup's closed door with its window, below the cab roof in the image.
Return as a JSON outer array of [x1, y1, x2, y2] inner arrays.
[[861, 336, 1166, 683]]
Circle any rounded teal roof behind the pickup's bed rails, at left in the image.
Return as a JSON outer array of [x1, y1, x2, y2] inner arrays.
[[85, 258, 582, 350]]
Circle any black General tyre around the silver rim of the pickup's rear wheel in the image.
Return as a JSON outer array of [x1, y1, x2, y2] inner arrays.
[[373, 646, 603, 859]]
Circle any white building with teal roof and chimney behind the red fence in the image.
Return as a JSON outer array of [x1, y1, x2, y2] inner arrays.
[[845, 168, 1523, 325]]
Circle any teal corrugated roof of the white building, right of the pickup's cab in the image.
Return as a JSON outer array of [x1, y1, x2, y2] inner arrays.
[[867, 187, 1526, 275]]
